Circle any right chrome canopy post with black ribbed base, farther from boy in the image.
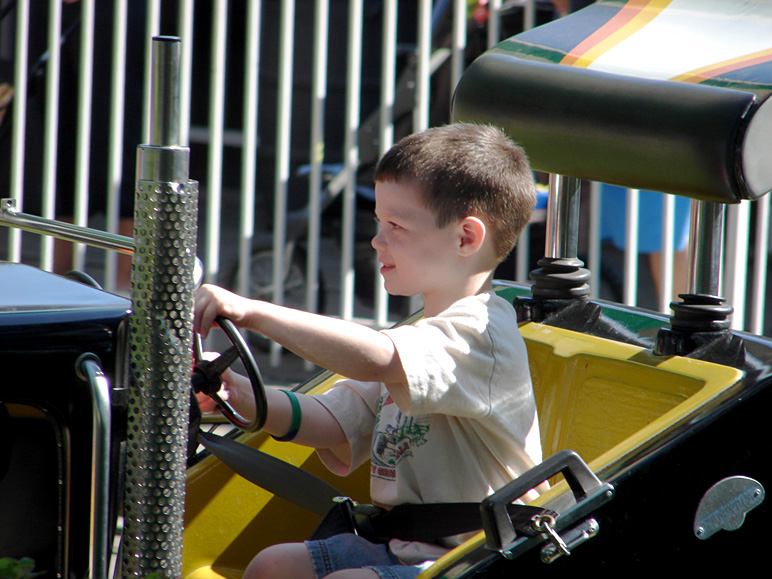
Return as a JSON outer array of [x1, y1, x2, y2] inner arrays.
[[654, 201, 745, 360]]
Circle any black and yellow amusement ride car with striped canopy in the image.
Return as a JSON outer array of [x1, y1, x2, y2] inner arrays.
[[0, 0, 772, 579]]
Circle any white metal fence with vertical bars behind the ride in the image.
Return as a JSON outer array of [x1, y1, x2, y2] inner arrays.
[[0, 0, 769, 356]]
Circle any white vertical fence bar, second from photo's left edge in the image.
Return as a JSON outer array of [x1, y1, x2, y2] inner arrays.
[[40, 0, 62, 270]]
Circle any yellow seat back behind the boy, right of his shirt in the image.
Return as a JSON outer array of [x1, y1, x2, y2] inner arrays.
[[520, 323, 743, 462]]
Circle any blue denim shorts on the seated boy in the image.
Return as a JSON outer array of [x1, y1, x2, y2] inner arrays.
[[306, 534, 427, 579]]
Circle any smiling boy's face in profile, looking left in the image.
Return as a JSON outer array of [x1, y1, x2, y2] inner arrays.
[[372, 182, 457, 300]]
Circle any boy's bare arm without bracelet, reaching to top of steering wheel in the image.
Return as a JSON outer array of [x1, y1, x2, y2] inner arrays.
[[194, 285, 408, 400]]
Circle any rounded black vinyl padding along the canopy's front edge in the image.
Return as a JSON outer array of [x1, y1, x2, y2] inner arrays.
[[453, 49, 772, 203]]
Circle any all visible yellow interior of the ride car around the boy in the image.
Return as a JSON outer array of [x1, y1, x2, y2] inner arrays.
[[183, 290, 743, 579]]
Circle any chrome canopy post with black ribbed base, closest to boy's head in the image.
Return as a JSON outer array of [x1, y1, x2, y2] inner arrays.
[[515, 174, 590, 321]]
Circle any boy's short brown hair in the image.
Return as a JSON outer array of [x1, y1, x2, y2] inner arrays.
[[375, 123, 536, 261]]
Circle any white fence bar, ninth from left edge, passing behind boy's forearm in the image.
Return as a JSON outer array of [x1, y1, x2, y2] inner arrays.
[[271, 0, 295, 366]]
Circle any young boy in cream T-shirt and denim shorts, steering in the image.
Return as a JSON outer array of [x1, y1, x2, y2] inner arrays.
[[195, 124, 541, 579]]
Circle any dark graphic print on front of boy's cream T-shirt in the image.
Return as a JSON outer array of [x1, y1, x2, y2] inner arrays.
[[371, 393, 429, 480]]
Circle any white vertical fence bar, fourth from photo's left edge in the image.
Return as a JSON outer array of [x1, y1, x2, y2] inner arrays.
[[105, 0, 128, 291]]
